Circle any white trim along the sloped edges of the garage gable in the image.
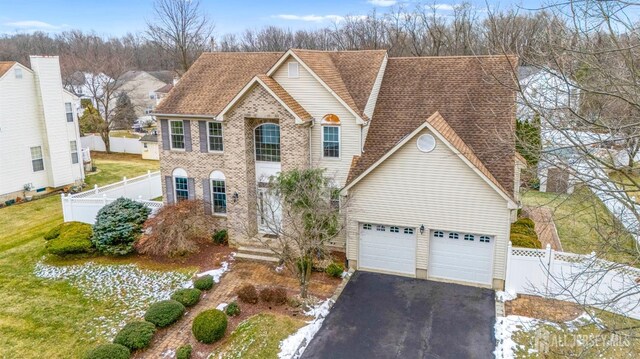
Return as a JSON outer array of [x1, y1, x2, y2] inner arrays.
[[342, 112, 518, 209]]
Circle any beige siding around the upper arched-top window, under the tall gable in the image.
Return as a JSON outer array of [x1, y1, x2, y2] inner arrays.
[[273, 59, 361, 187]]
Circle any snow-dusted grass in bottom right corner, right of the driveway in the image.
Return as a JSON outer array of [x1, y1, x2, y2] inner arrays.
[[512, 311, 640, 359]]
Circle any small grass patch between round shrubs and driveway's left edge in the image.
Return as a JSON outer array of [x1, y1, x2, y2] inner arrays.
[[211, 313, 305, 359]]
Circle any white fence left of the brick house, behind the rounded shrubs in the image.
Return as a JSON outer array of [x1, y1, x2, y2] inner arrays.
[[61, 171, 162, 224]]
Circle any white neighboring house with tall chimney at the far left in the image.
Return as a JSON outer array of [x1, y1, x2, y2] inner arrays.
[[0, 56, 84, 200]]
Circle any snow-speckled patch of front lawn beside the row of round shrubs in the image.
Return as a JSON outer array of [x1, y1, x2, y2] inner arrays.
[[34, 262, 191, 340]]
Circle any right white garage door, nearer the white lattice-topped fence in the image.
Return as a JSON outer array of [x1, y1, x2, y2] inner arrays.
[[429, 230, 494, 285]]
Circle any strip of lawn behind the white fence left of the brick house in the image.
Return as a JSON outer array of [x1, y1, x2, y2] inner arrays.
[[85, 152, 160, 187]]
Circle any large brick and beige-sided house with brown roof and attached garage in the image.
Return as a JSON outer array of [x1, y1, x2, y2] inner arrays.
[[155, 50, 521, 288]]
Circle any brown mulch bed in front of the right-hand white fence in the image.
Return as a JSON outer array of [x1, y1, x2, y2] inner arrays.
[[504, 294, 583, 323]]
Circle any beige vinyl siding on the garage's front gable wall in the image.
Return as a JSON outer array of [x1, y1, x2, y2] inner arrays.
[[347, 129, 510, 279]]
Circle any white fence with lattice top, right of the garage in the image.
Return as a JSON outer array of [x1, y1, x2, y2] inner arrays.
[[505, 244, 640, 319]]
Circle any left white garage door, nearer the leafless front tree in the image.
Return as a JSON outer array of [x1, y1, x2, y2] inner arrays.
[[358, 223, 416, 276]]
